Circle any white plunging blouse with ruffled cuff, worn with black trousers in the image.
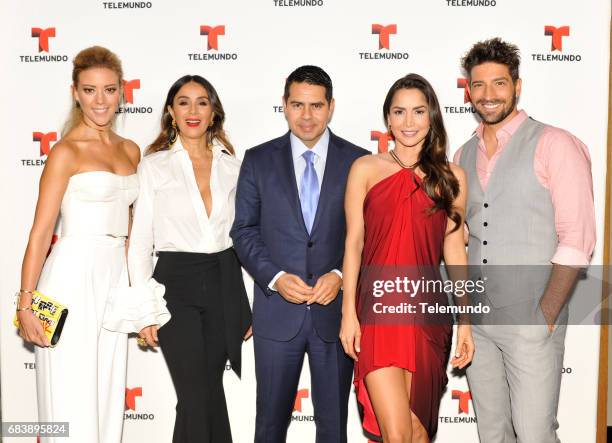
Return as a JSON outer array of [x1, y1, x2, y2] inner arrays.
[[103, 139, 240, 332]]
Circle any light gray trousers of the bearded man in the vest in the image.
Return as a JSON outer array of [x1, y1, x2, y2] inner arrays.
[[467, 304, 567, 443]]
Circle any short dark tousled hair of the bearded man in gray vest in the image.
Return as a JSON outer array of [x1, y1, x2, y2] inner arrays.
[[461, 37, 521, 82]]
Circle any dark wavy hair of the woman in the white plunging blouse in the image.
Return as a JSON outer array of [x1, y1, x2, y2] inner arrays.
[[145, 75, 235, 155]]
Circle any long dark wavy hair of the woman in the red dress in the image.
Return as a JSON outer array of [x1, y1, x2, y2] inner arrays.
[[383, 74, 461, 231]]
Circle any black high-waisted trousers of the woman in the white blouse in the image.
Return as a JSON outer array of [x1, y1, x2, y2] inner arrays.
[[153, 252, 232, 443]]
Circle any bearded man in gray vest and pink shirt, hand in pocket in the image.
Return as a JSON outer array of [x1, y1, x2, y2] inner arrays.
[[455, 38, 595, 443]]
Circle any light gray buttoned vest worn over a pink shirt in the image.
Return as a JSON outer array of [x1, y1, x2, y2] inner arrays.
[[459, 119, 558, 307]]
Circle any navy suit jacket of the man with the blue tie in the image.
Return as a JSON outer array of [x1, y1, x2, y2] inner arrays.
[[230, 131, 370, 342]]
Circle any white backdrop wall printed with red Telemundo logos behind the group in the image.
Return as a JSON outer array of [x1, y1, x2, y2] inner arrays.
[[0, 0, 610, 443]]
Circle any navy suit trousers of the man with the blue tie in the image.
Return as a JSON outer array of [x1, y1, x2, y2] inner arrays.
[[254, 309, 353, 443]]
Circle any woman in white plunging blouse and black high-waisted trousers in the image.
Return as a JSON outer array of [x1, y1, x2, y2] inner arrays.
[[128, 75, 251, 443]]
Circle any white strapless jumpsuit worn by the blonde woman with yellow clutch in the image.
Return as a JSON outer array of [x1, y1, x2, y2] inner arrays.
[[36, 171, 138, 443]]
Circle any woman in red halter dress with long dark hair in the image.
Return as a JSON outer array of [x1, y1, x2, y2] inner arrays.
[[340, 74, 474, 443]]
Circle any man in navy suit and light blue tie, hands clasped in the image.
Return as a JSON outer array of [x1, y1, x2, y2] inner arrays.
[[230, 66, 369, 443]]
